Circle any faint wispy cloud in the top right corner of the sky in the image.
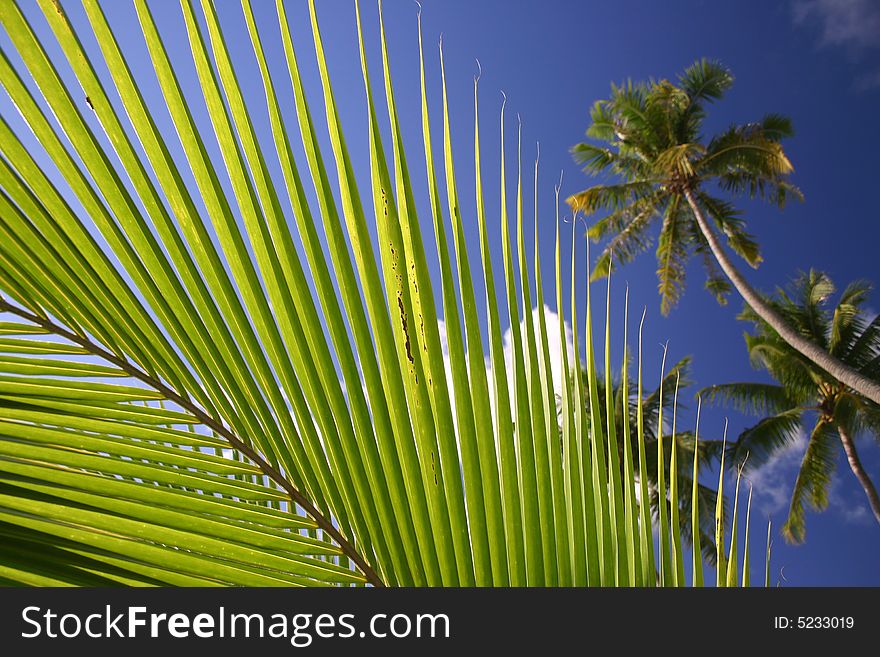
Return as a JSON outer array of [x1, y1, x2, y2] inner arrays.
[[792, 0, 880, 90]]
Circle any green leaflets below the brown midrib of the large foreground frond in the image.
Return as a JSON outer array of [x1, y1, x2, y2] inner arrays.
[[0, 334, 364, 586]]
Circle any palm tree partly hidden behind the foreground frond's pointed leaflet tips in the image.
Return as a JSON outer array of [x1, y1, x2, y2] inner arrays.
[[584, 357, 726, 564]]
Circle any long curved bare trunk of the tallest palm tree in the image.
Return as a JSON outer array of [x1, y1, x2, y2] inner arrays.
[[684, 189, 880, 404]]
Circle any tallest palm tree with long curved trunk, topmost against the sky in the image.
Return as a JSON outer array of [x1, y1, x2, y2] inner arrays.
[[568, 59, 880, 403]]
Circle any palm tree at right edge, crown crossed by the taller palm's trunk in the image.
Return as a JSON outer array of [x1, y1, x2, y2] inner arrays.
[[705, 270, 880, 543]]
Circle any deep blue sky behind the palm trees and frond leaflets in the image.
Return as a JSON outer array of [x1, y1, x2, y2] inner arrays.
[[0, 0, 880, 585]]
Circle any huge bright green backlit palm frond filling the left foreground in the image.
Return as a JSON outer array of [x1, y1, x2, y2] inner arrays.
[[0, 0, 748, 586]]
